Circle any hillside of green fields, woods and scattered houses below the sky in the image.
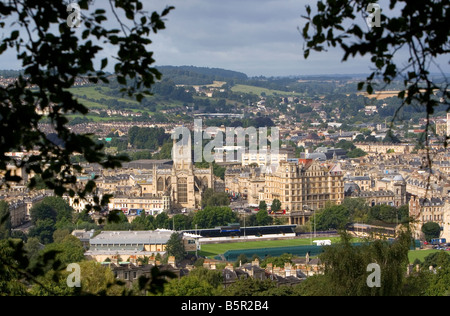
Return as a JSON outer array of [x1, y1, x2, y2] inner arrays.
[[4, 66, 446, 130]]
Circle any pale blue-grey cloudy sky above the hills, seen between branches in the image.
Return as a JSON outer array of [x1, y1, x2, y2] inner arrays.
[[0, 0, 449, 77]]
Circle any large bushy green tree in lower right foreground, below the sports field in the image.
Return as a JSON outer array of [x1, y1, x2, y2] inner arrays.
[[305, 233, 411, 296]]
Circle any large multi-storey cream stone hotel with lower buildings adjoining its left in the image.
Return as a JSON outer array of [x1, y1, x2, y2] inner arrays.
[[229, 159, 344, 213]]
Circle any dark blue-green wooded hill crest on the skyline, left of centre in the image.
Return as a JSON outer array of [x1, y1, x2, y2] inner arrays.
[[156, 66, 248, 85]]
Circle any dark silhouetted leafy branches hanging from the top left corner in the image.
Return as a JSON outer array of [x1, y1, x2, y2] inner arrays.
[[0, 0, 173, 209]]
